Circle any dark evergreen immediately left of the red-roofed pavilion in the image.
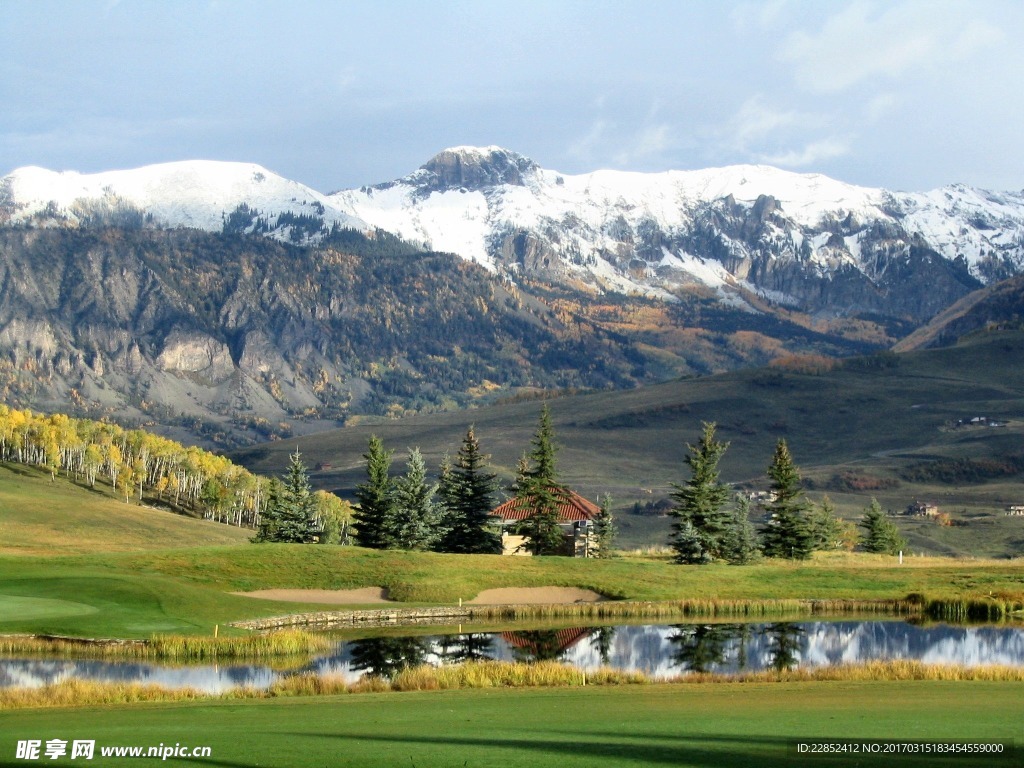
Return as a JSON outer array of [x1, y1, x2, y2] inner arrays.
[[438, 426, 502, 554]]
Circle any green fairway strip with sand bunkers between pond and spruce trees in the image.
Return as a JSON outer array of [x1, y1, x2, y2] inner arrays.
[[0, 544, 1024, 639]]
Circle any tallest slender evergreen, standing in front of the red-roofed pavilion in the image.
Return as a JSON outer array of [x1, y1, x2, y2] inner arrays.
[[516, 406, 565, 555]]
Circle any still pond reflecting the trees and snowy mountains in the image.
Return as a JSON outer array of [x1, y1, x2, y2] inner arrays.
[[0, 621, 1024, 692]]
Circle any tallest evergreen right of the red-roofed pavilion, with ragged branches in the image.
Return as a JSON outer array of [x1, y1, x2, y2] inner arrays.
[[669, 422, 730, 563]]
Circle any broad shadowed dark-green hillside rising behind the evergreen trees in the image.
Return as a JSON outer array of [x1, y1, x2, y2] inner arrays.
[[234, 332, 1024, 556]]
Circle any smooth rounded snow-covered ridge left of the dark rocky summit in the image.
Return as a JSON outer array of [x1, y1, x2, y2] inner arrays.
[[0, 161, 367, 241]]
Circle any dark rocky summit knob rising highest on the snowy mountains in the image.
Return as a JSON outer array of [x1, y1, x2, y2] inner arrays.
[[417, 146, 540, 191]]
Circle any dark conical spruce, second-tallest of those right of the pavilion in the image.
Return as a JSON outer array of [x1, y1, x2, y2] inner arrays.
[[761, 439, 813, 560]]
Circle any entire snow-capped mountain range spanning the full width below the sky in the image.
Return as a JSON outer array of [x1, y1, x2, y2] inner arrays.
[[0, 146, 1024, 322]]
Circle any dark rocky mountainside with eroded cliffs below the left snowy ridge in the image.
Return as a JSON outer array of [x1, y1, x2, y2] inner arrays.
[[0, 228, 733, 445]]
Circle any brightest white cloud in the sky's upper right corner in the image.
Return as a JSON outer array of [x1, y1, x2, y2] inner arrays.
[[779, 0, 1002, 92]]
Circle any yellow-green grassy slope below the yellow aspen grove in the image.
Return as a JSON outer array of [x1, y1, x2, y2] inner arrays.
[[0, 464, 252, 555]]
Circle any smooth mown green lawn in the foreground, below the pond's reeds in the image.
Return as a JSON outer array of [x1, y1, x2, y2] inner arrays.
[[0, 682, 1024, 768]]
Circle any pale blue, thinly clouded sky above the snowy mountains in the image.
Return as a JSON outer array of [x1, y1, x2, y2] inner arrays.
[[0, 0, 1024, 193]]
